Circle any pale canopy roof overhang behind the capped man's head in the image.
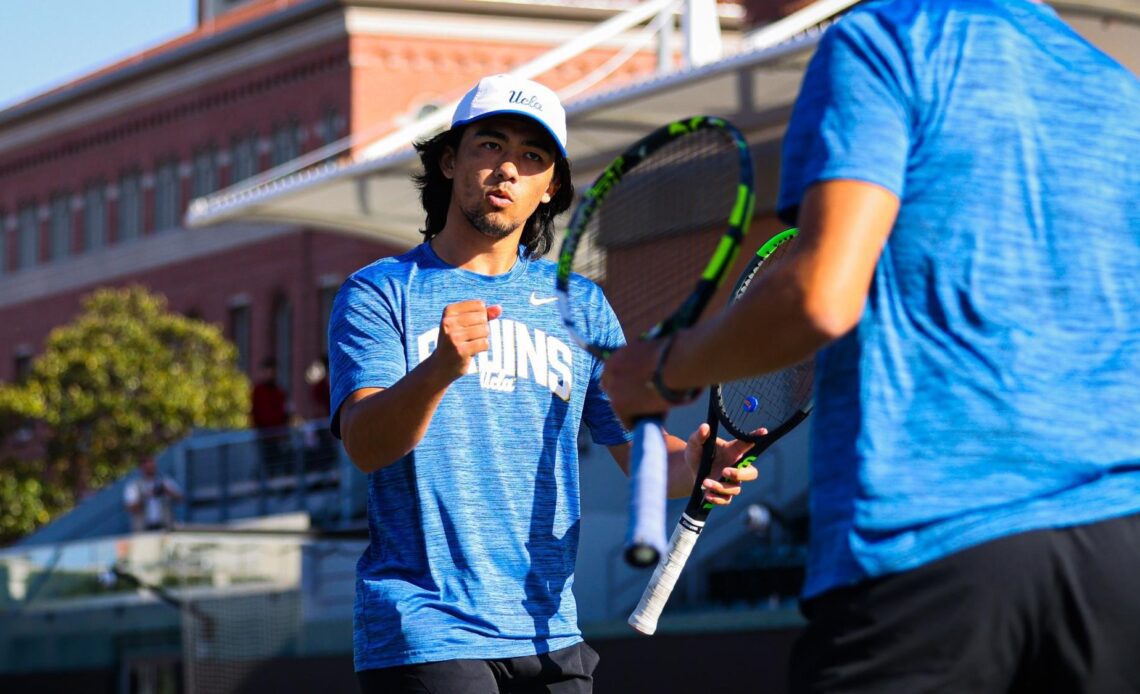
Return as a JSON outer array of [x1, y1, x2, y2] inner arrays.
[[186, 0, 1140, 245]]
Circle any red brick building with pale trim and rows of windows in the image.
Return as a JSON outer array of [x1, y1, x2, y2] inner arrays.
[[0, 0, 738, 418]]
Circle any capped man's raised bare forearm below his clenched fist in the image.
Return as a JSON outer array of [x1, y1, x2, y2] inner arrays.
[[341, 358, 451, 473]]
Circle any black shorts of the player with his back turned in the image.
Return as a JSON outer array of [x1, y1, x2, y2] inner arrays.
[[790, 515, 1140, 694]]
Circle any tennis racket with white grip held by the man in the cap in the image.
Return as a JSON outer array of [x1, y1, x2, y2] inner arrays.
[[629, 229, 814, 635]]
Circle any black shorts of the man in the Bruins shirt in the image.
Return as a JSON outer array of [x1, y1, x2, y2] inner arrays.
[[357, 642, 597, 694]]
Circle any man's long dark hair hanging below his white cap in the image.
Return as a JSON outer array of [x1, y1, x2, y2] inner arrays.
[[413, 125, 573, 259]]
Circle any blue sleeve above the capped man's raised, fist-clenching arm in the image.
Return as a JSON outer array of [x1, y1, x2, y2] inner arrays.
[[328, 275, 407, 439]]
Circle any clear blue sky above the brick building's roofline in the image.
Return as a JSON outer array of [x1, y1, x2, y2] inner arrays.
[[0, 0, 197, 111]]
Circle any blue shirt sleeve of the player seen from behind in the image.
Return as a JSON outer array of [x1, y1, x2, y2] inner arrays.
[[776, 11, 914, 226]]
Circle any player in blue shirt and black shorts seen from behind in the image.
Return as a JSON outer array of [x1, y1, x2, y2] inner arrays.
[[603, 0, 1140, 693]]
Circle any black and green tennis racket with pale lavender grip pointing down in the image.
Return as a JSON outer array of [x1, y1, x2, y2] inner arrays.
[[555, 116, 756, 566]]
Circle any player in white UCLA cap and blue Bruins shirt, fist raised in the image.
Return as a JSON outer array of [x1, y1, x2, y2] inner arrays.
[[328, 75, 756, 694]]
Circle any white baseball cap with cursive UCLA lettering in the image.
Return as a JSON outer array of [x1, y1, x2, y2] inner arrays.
[[451, 74, 567, 156]]
